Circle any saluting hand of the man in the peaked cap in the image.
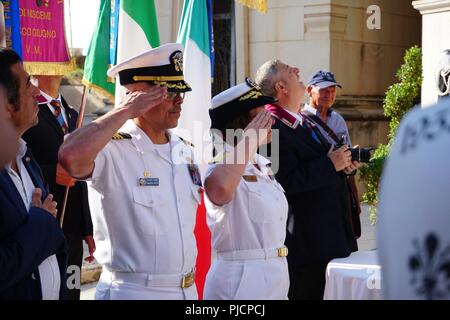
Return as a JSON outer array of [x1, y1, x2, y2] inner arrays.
[[120, 83, 167, 119]]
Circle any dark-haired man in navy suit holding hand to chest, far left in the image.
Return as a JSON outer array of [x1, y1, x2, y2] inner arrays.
[[0, 48, 67, 300]]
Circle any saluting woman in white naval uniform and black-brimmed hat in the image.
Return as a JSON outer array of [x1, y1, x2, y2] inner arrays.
[[204, 79, 289, 300]]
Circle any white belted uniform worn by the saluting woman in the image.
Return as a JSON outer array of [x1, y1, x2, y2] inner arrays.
[[204, 150, 289, 300]]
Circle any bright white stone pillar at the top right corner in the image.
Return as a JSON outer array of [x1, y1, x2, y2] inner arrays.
[[412, 0, 450, 107]]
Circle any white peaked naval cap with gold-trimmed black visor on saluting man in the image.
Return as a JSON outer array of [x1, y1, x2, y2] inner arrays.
[[107, 43, 192, 92]]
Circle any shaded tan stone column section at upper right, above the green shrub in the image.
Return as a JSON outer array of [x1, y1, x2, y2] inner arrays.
[[330, 0, 421, 96]]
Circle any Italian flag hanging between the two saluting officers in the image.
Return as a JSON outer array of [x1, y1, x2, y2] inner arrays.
[[176, 0, 213, 299]]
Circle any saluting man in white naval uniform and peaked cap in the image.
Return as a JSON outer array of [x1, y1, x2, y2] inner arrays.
[[59, 44, 201, 299]]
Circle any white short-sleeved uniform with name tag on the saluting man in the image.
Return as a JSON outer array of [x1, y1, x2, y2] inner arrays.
[[89, 120, 201, 299]]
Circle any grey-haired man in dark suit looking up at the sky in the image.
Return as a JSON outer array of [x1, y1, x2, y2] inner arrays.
[[256, 60, 359, 299]]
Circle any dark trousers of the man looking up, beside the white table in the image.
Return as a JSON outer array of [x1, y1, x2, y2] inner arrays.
[[288, 263, 327, 300]]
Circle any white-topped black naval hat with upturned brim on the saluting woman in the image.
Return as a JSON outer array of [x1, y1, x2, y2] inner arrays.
[[209, 78, 277, 130]]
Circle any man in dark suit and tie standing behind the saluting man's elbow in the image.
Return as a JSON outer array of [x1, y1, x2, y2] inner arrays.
[[23, 75, 95, 300]]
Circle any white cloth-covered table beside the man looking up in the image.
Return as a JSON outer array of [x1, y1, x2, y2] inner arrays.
[[323, 251, 382, 300]]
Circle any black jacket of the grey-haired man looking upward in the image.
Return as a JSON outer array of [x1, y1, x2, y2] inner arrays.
[[269, 119, 357, 266]]
